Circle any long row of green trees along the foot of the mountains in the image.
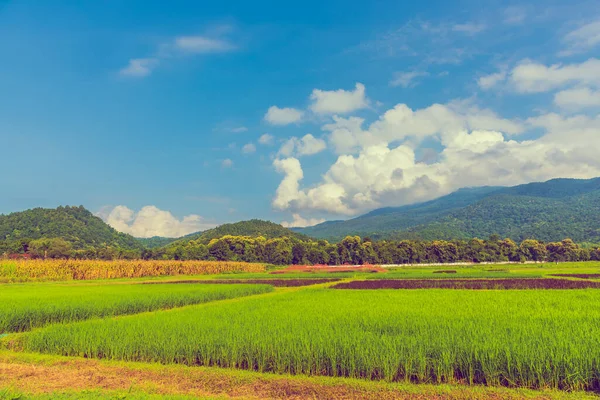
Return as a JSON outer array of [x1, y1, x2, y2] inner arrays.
[[4, 235, 600, 265]]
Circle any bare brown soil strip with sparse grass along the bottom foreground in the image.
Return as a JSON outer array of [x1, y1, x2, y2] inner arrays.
[[0, 351, 593, 400]]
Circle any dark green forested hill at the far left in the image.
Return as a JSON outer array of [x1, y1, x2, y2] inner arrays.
[[0, 206, 142, 250]]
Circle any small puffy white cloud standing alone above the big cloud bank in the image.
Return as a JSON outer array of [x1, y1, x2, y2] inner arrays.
[[310, 83, 369, 114]]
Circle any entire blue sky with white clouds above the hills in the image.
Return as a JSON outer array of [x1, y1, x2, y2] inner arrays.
[[0, 0, 600, 237]]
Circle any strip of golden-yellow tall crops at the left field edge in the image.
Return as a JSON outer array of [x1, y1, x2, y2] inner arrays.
[[0, 260, 265, 282]]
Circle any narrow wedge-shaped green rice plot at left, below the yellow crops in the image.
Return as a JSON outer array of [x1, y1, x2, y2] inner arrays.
[[0, 284, 273, 334]]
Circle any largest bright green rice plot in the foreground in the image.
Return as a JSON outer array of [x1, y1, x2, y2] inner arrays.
[[21, 288, 600, 390]]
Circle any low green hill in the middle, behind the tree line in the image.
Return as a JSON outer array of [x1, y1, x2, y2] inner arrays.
[[171, 219, 308, 243]]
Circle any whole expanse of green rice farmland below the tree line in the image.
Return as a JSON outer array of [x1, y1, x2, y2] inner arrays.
[[0, 262, 600, 398]]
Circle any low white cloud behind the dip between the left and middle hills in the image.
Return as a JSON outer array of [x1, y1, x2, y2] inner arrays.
[[105, 205, 215, 238]]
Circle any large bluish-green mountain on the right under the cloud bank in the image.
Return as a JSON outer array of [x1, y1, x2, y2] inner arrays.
[[295, 178, 600, 242]]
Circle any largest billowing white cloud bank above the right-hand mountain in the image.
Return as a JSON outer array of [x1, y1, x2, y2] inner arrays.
[[273, 102, 600, 216]]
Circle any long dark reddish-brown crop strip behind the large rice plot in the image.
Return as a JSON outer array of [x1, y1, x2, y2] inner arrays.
[[332, 278, 600, 290]]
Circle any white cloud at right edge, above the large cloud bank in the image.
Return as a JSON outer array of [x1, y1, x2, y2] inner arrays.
[[510, 58, 600, 93]]
